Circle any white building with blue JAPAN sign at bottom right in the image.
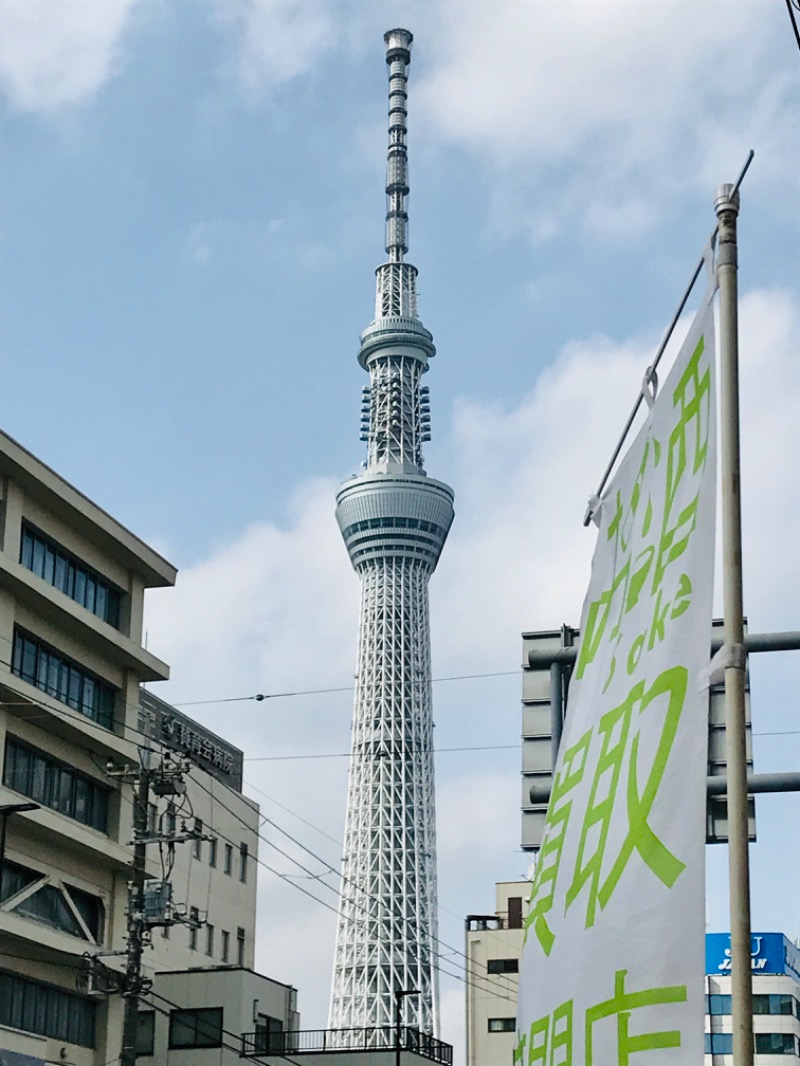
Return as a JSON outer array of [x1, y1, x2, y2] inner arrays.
[[704, 933, 800, 1066]]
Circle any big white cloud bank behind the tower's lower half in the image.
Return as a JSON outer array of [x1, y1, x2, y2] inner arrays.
[[148, 290, 800, 1043]]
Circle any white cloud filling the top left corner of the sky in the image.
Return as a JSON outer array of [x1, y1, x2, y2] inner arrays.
[[0, 0, 137, 113]]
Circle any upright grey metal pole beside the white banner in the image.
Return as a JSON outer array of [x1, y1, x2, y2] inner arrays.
[[714, 184, 753, 1066]]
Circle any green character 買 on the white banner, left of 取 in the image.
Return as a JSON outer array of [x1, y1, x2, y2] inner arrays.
[[525, 730, 592, 955]]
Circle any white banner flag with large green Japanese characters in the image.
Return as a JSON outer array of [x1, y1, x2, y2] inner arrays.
[[514, 287, 716, 1066]]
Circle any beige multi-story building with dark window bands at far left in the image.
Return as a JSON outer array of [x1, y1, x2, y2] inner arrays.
[[0, 424, 176, 1066]]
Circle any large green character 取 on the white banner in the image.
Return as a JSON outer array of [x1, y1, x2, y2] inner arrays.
[[565, 666, 688, 928]]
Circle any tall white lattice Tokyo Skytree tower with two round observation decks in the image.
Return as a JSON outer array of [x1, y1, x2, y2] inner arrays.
[[330, 30, 453, 1035]]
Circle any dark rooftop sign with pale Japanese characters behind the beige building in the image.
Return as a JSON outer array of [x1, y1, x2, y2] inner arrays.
[[139, 689, 242, 792]]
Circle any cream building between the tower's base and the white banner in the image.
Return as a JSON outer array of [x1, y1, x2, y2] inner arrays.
[[465, 881, 530, 1066]]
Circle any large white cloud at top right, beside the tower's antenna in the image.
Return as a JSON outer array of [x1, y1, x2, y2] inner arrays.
[[415, 0, 800, 240]]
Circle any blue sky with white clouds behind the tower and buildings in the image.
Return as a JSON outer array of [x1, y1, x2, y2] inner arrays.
[[0, 0, 800, 1057]]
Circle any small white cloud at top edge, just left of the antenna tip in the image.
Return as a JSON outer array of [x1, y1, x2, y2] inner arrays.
[[213, 0, 337, 93]]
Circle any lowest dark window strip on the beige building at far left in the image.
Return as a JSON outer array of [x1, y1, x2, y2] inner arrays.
[[0, 971, 95, 1048]]
